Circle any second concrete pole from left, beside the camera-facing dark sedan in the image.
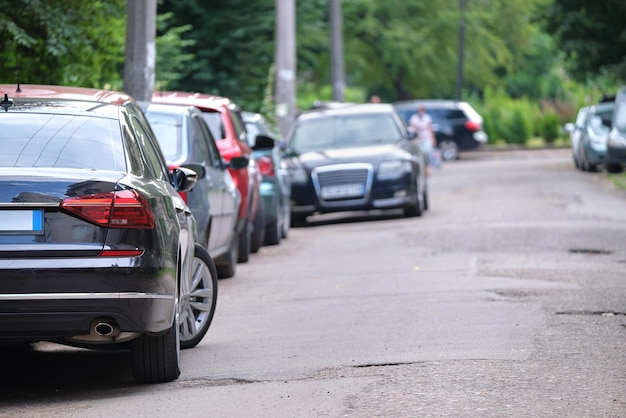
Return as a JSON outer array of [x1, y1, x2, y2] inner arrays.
[[274, 0, 296, 137]]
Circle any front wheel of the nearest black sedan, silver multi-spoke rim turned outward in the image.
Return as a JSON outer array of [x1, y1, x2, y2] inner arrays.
[[180, 244, 217, 349]]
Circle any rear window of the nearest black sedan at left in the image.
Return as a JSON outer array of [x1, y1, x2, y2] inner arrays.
[[0, 112, 126, 171]]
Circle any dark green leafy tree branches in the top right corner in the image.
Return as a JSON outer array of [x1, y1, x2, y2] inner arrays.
[[545, 0, 626, 83]]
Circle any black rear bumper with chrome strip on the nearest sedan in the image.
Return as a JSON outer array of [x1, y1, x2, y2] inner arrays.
[[0, 258, 176, 341]]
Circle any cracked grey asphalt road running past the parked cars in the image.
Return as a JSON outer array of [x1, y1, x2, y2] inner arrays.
[[0, 149, 626, 418]]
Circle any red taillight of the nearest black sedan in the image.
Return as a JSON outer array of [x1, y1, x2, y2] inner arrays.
[[61, 190, 154, 229]]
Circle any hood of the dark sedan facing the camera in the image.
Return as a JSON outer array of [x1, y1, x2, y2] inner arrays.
[[296, 145, 415, 169]]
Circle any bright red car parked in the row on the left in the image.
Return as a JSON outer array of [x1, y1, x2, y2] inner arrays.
[[152, 91, 265, 263]]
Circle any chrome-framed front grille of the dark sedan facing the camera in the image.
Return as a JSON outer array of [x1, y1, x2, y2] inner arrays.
[[311, 164, 374, 206]]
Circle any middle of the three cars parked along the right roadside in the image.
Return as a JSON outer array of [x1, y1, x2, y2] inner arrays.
[[576, 102, 614, 171]]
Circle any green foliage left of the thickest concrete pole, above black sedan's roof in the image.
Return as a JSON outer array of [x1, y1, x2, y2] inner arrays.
[[0, 0, 126, 87]]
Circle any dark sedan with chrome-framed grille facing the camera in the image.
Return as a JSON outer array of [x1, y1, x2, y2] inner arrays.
[[284, 104, 428, 221]]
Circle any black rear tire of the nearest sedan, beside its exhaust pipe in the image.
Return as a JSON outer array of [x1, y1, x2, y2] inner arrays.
[[131, 316, 180, 383]]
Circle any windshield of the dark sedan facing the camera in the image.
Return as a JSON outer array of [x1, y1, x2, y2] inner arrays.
[[291, 114, 402, 152]]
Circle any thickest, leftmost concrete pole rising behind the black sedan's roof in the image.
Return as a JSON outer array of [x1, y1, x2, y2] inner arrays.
[[123, 0, 157, 101]]
